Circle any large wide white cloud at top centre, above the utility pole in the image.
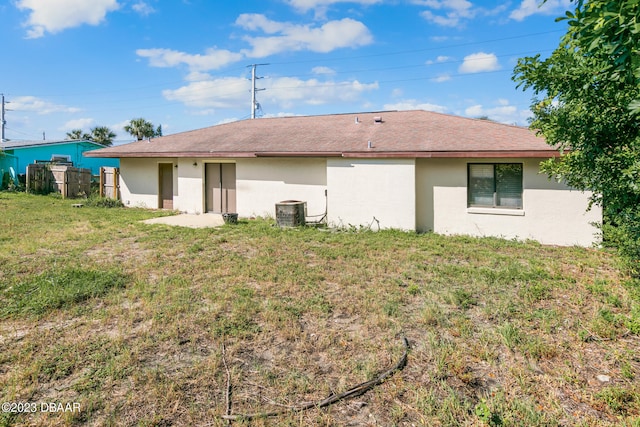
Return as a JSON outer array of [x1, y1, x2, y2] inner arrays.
[[236, 14, 373, 58]]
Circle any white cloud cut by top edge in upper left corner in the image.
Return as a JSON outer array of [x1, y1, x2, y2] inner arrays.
[[16, 0, 120, 38]]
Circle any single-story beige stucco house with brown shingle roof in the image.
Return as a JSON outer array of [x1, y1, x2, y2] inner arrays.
[[87, 111, 602, 246]]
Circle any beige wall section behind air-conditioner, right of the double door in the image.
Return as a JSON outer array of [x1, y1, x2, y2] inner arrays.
[[236, 158, 327, 219]]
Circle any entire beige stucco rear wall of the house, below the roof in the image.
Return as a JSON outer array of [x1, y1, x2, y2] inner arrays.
[[120, 158, 602, 246]]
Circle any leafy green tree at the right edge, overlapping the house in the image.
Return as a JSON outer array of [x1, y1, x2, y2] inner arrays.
[[513, 0, 640, 266]]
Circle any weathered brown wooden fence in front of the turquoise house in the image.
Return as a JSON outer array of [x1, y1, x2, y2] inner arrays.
[[26, 164, 91, 198]]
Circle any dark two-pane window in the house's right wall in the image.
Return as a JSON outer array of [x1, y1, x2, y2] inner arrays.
[[468, 163, 522, 209]]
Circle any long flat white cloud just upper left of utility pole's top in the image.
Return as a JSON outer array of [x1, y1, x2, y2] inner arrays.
[[136, 48, 244, 72]]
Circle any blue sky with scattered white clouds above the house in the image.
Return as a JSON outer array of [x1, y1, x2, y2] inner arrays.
[[0, 0, 570, 141]]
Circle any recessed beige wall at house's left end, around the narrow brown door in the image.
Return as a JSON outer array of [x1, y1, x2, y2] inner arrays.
[[120, 158, 178, 209]]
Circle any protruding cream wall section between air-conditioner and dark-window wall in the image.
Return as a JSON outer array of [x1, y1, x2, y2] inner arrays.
[[327, 158, 416, 230]]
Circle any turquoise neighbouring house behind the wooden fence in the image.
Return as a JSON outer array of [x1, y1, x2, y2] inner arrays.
[[0, 140, 120, 175]]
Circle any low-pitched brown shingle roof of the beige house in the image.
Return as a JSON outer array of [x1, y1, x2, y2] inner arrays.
[[87, 111, 557, 158]]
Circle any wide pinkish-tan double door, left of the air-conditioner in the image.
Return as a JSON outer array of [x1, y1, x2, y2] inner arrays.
[[205, 163, 236, 213]]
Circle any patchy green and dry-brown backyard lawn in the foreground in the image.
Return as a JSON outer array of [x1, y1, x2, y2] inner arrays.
[[0, 193, 640, 426]]
